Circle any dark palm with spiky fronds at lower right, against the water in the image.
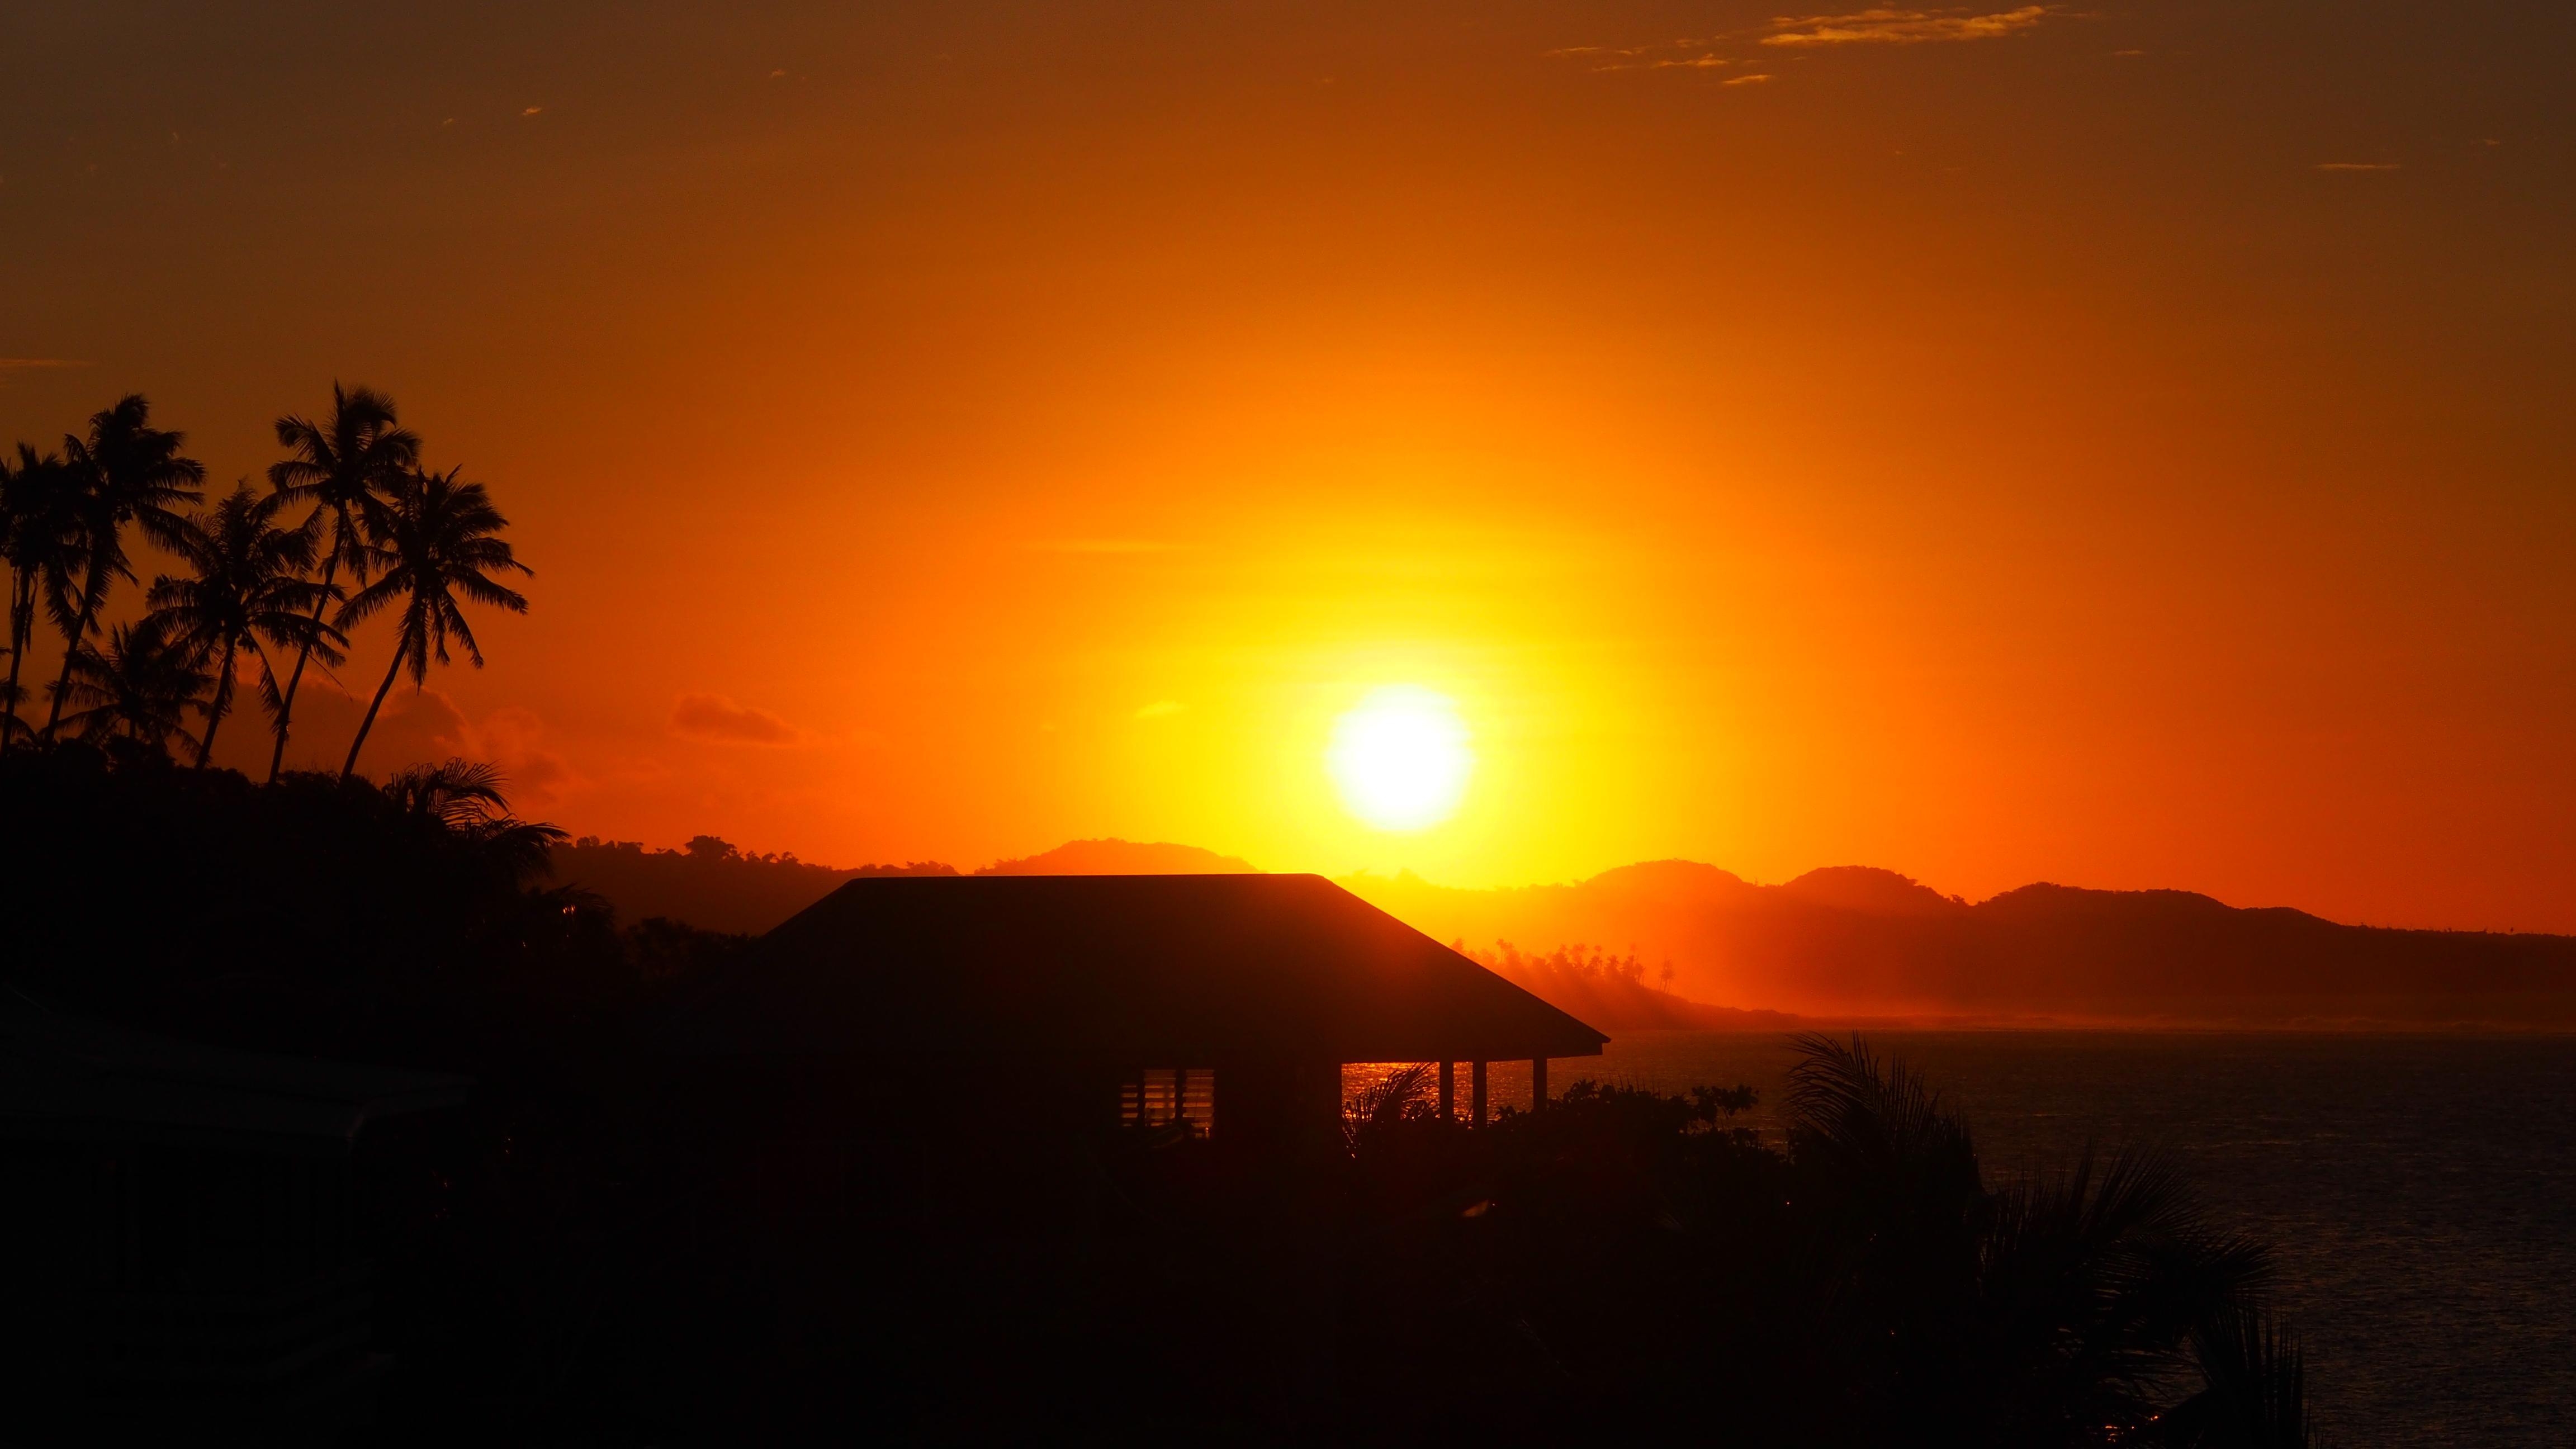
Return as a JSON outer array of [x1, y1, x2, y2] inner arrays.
[[1788, 1036, 2300, 1444]]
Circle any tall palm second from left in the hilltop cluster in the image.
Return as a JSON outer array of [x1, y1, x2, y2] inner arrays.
[[44, 392, 206, 737]]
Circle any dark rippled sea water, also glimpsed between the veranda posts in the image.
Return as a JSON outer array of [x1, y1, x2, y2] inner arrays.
[[1360, 1031, 2576, 1449]]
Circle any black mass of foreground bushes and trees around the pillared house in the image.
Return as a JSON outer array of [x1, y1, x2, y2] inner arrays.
[[0, 742, 2308, 1446]]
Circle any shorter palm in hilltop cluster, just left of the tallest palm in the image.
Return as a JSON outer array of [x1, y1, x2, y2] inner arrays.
[[152, 482, 345, 768]]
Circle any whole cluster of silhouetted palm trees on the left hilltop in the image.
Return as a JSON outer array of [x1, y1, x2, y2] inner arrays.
[[0, 384, 531, 784]]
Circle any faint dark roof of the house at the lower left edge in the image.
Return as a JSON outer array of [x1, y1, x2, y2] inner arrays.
[[0, 987, 469, 1145]]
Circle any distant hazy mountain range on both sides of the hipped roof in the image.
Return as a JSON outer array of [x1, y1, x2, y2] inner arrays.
[[554, 835, 2576, 1031]]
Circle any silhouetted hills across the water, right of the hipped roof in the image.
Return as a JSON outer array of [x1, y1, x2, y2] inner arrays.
[[1344, 861, 2576, 1024]]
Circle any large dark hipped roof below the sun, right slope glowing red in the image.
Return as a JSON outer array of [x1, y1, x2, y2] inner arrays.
[[670, 874, 1607, 1067]]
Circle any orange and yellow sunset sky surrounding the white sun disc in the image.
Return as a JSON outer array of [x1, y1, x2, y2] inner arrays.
[[0, 0, 2576, 931]]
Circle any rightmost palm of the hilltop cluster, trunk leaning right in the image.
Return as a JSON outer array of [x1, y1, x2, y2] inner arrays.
[[340, 469, 536, 781]]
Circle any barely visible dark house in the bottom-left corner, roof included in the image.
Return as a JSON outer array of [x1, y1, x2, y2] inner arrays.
[[0, 987, 466, 1441]]
